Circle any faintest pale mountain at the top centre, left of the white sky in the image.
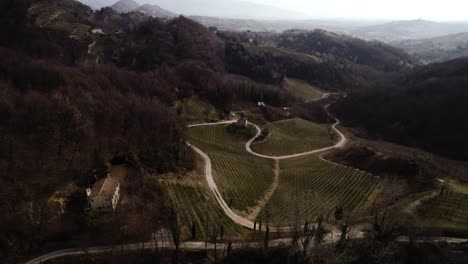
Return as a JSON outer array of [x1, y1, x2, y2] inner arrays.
[[147, 0, 307, 19]]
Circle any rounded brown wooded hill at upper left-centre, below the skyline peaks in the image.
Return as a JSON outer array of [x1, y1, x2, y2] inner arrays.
[[102, 17, 224, 72]]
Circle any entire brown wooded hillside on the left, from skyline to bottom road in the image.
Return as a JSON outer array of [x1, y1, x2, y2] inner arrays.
[[0, 0, 300, 263]]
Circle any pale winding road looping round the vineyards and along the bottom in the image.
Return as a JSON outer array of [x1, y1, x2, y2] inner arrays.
[[25, 93, 468, 264]]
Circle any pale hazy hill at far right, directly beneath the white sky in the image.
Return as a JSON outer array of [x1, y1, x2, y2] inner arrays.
[[350, 20, 468, 42]]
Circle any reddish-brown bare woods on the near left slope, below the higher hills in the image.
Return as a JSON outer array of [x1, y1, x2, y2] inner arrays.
[[0, 48, 191, 262]]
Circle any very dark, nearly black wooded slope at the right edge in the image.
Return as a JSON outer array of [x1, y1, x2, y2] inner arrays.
[[335, 58, 468, 160]]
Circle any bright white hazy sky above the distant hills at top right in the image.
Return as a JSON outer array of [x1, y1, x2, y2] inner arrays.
[[247, 0, 468, 21]]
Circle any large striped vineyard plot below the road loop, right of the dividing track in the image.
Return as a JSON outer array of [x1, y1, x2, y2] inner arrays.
[[260, 155, 378, 225]]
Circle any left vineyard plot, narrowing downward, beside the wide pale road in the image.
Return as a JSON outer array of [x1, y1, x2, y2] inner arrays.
[[189, 125, 274, 216]]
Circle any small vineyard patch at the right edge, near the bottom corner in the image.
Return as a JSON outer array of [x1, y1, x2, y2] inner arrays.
[[419, 191, 468, 232]]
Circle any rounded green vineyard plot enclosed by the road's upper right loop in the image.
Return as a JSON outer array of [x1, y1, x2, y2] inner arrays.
[[251, 118, 334, 156]]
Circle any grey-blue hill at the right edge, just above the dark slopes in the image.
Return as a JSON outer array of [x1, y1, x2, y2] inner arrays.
[[389, 32, 468, 63]]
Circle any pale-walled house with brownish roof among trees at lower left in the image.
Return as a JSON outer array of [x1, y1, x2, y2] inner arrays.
[[86, 177, 120, 213]]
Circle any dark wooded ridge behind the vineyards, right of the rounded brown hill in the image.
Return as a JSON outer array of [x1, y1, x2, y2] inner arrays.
[[223, 35, 389, 91]]
